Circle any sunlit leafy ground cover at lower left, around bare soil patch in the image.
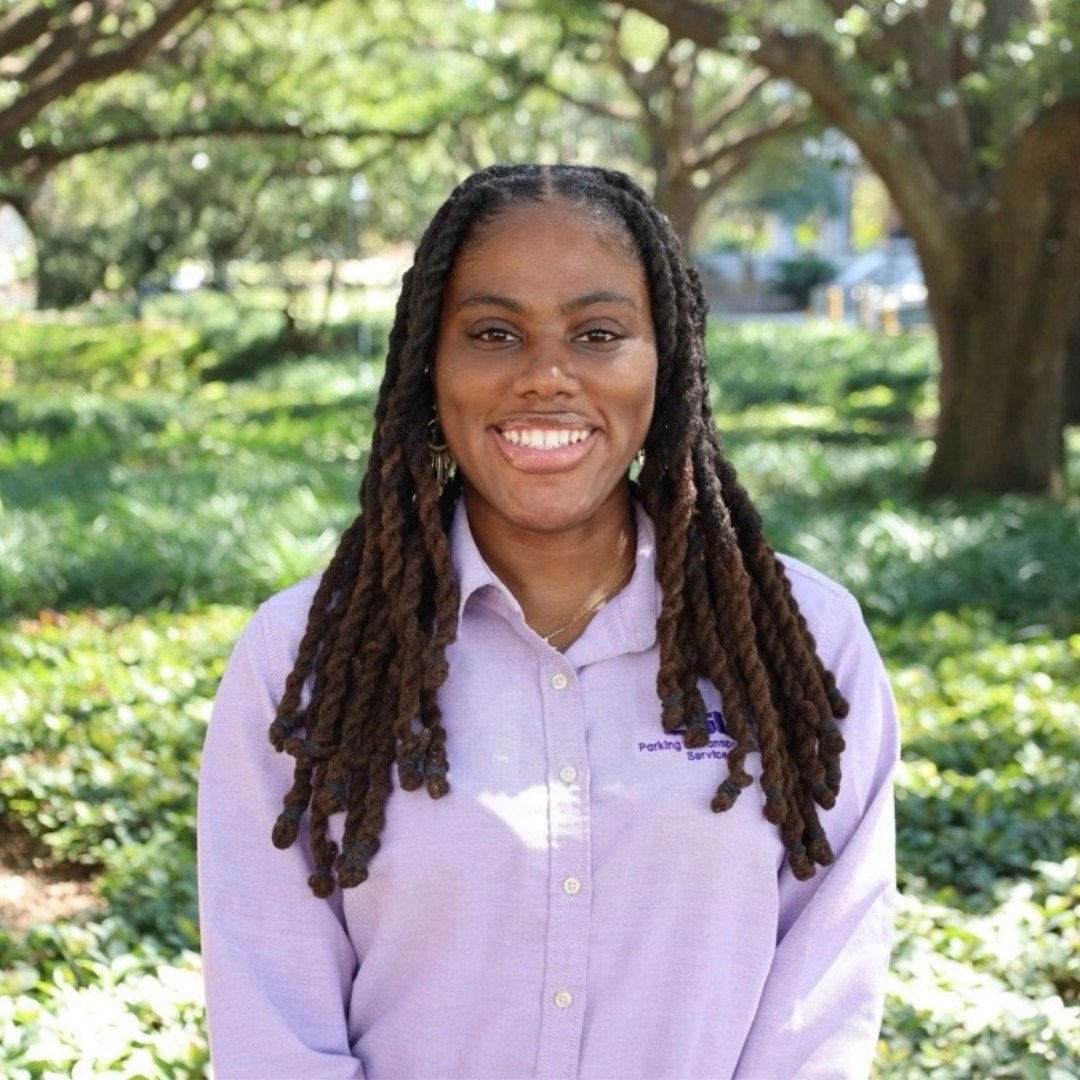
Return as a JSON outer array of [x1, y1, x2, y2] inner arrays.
[[0, 608, 246, 1080]]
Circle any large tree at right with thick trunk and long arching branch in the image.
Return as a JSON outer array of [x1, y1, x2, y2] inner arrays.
[[626, 0, 1080, 494]]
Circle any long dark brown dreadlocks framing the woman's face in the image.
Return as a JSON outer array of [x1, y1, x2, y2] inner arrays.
[[270, 159, 848, 896]]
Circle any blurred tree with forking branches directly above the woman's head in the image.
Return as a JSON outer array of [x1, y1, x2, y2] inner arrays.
[[473, 0, 807, 247]]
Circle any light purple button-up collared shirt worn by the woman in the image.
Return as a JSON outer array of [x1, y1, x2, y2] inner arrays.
[[199, 507, 897, 1080]]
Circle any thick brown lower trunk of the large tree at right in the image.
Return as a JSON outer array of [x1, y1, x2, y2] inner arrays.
[[916, 139, 1080, 496]]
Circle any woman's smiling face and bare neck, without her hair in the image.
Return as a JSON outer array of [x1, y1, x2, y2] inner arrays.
[[435, 202, 657, 630]]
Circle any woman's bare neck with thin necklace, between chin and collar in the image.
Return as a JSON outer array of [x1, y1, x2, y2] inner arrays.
[[465, 487, 637, 648]]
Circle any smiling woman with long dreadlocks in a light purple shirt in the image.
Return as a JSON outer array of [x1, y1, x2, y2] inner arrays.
[[200, 165, 896, 1080]]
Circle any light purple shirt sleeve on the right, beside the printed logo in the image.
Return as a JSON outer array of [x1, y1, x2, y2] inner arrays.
[[735, 593, 900, 1080]]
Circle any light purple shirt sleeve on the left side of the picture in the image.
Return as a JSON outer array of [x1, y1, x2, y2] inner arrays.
[[198, 608, 363, 1080]]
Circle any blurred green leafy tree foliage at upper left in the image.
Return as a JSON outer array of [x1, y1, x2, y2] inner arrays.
[[0, 0, 548, 306]]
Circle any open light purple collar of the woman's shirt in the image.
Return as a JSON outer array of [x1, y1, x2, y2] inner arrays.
[[450, 499, 661, 665]]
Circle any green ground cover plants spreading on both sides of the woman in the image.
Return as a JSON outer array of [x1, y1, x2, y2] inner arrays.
[[0, 306, 1080, 1080]]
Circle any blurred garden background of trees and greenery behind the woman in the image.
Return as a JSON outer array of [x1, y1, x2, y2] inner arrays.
[[0, 0, 1080, 1080]]
